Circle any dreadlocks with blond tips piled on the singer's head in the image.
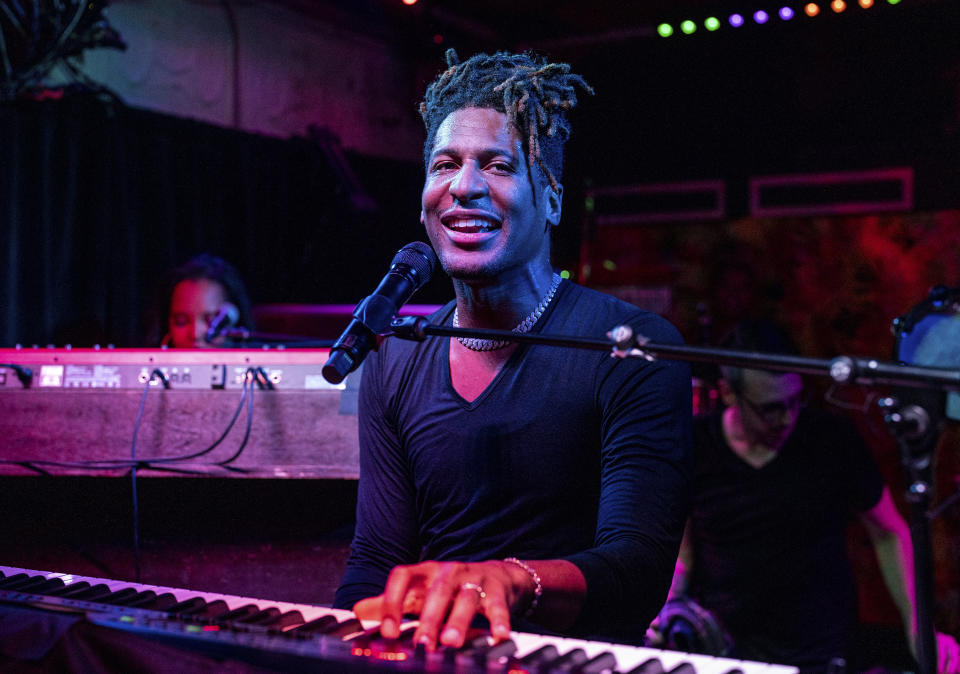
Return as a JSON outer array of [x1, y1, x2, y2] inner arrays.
[[420, 49, 593, 193]]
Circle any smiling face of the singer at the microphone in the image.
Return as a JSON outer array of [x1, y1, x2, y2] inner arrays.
[[420, 108, 560, 279]]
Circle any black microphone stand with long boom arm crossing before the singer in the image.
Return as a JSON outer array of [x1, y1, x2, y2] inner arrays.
[[386, 316, 960, 674]]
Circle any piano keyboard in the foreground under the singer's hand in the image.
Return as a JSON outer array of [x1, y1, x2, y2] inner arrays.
[[0, 566, 797, 674]]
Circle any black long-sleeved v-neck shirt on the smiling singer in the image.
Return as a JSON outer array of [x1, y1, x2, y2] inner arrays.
[[336, 281, 692, 632]]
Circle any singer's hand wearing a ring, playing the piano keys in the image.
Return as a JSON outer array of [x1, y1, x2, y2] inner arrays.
[[353, 561, 532, 650]]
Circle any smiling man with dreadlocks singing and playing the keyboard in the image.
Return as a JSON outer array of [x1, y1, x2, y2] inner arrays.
[[336, 51, 691, 648]]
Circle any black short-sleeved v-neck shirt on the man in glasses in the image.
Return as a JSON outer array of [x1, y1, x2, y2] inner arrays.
[[690, 409, 884, 664]]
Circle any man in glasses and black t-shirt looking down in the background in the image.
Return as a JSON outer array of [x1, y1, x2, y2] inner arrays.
[[655, 321, 958, 672]]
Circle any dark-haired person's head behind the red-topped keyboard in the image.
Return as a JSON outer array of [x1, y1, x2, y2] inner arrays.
[[151, 253, 253, 349]]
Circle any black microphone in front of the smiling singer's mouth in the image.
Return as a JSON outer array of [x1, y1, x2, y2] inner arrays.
[[322, 241, 437, 384]]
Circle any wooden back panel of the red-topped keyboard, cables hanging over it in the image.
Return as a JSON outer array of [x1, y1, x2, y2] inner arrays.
[[0, 389, 359, 479]]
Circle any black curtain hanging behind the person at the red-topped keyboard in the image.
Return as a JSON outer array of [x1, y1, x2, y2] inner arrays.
[[0, 96, 436, 346]]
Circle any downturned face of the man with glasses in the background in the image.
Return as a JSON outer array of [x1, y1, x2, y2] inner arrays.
[[734, 370, 803, 451]]
